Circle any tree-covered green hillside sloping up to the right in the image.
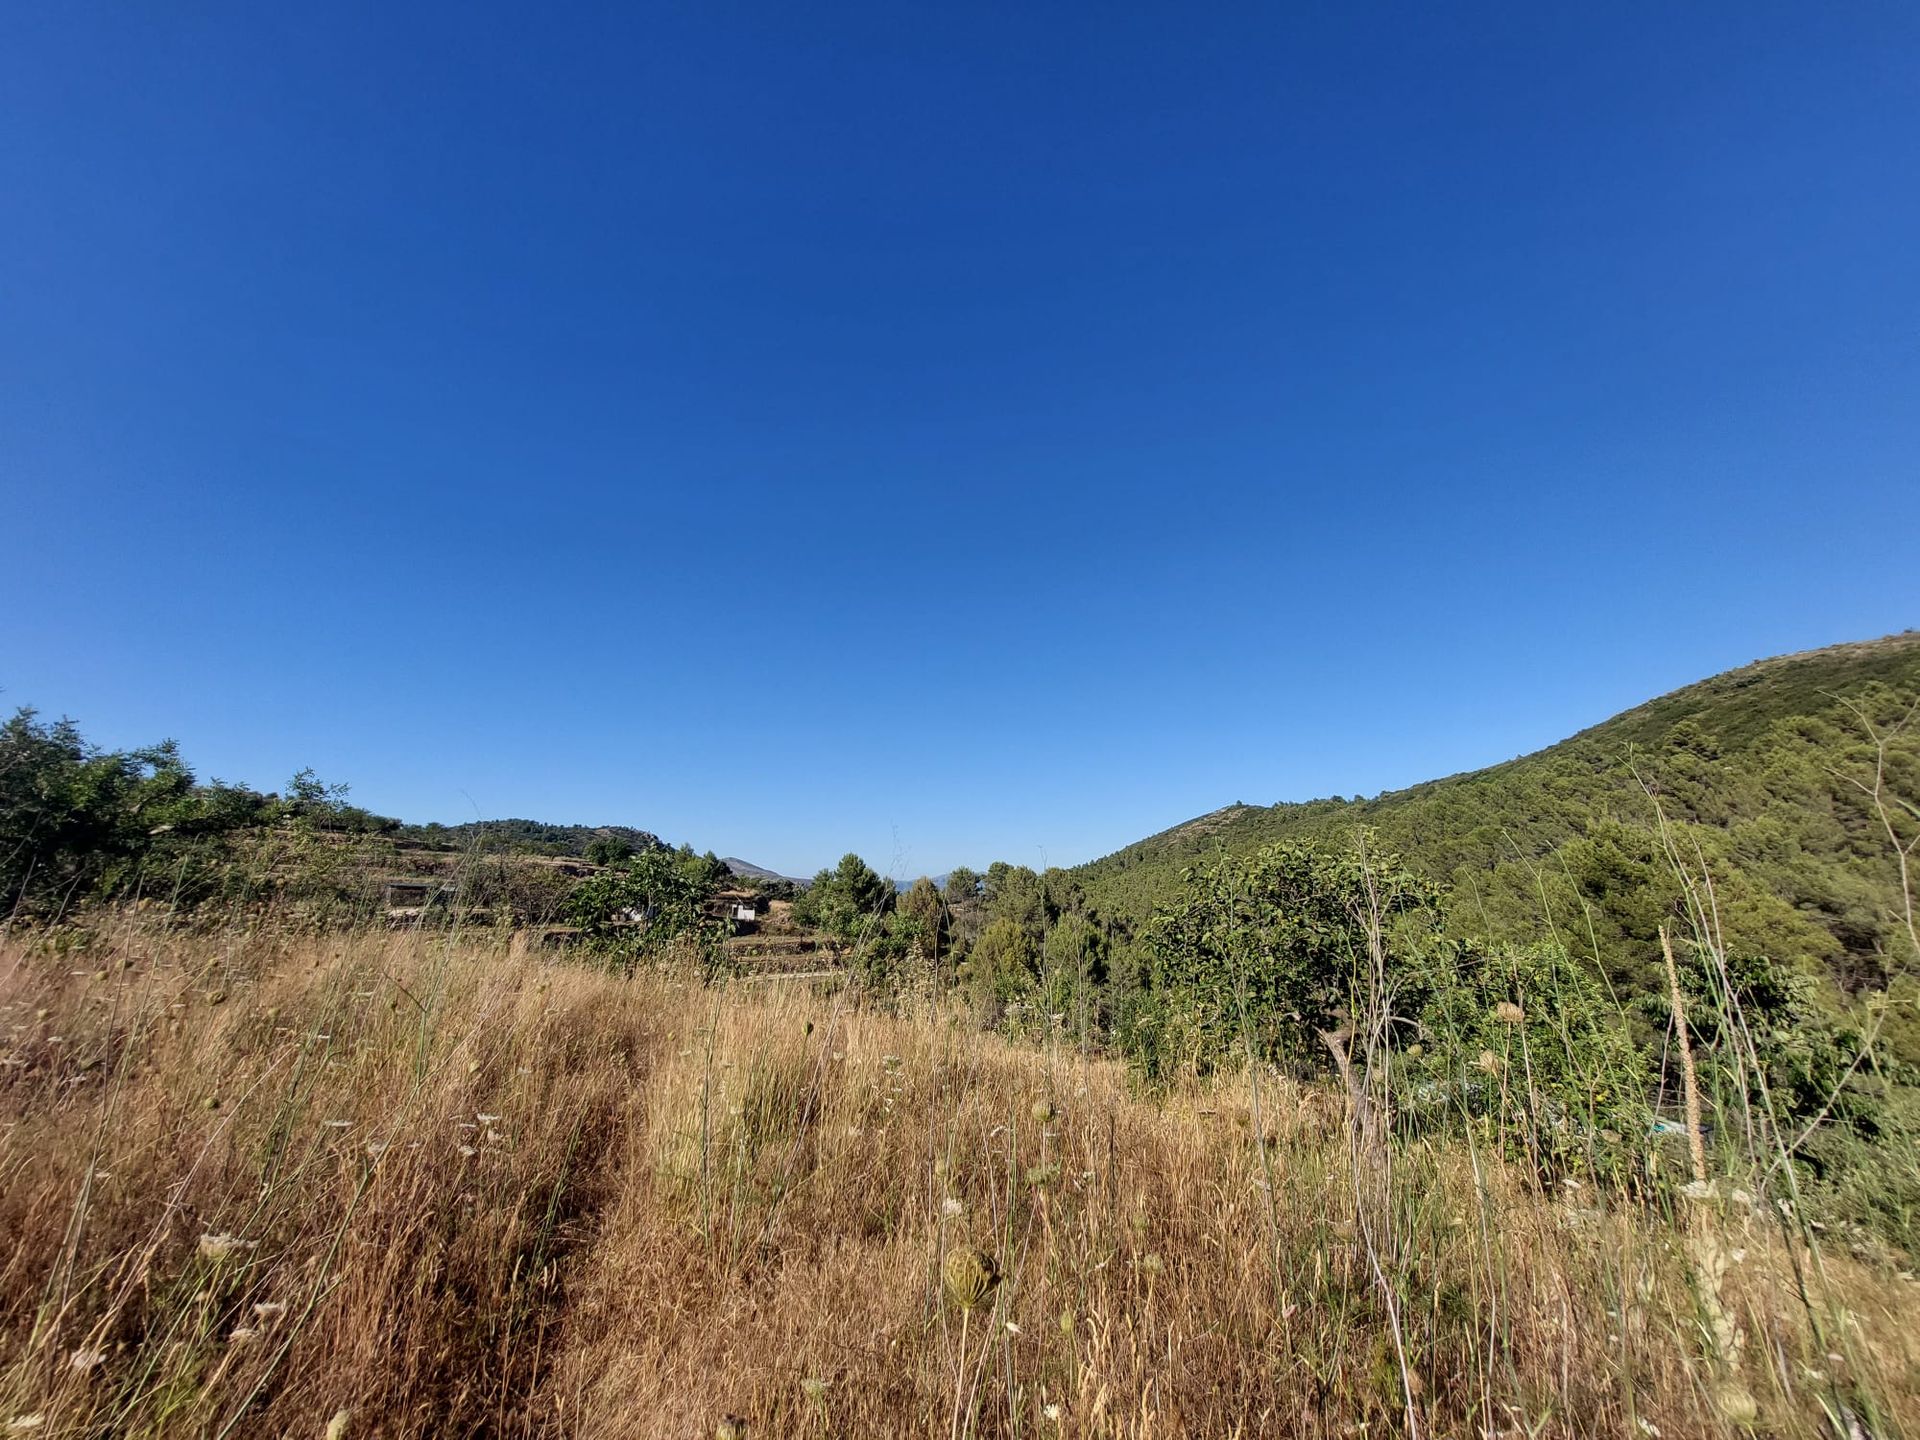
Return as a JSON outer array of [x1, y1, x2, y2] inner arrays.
[[1075, 632, 1920, 1056]]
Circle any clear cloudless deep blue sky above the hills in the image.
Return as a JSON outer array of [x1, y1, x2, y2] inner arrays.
[[0, 0, 1920, 874]]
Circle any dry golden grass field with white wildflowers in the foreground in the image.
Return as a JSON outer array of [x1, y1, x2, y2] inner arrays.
[[0, 927, 1920, 1438]]
